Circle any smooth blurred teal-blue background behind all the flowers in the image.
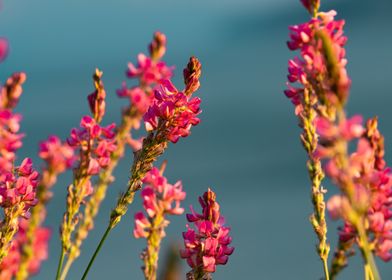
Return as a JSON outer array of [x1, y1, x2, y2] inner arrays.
[[0, 0, 392, 280]]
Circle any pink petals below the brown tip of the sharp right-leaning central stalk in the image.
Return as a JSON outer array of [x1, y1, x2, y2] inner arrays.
[[144, 80, 201, 143]]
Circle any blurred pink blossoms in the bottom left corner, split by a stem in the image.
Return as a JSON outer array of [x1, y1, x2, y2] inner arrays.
[[0, 220, 51, 280]]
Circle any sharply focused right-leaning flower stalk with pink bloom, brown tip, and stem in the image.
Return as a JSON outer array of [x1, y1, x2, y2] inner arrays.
[[82, 57, 201, 279]]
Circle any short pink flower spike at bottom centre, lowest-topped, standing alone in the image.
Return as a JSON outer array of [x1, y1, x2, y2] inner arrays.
[[180, 189, 234, 279]]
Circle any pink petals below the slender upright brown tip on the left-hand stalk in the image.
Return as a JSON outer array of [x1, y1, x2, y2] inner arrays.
[[67, 116, 116, 175]]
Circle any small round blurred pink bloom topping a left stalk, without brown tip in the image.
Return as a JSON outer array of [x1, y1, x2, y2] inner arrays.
[[39, 135, 75, 174]]
